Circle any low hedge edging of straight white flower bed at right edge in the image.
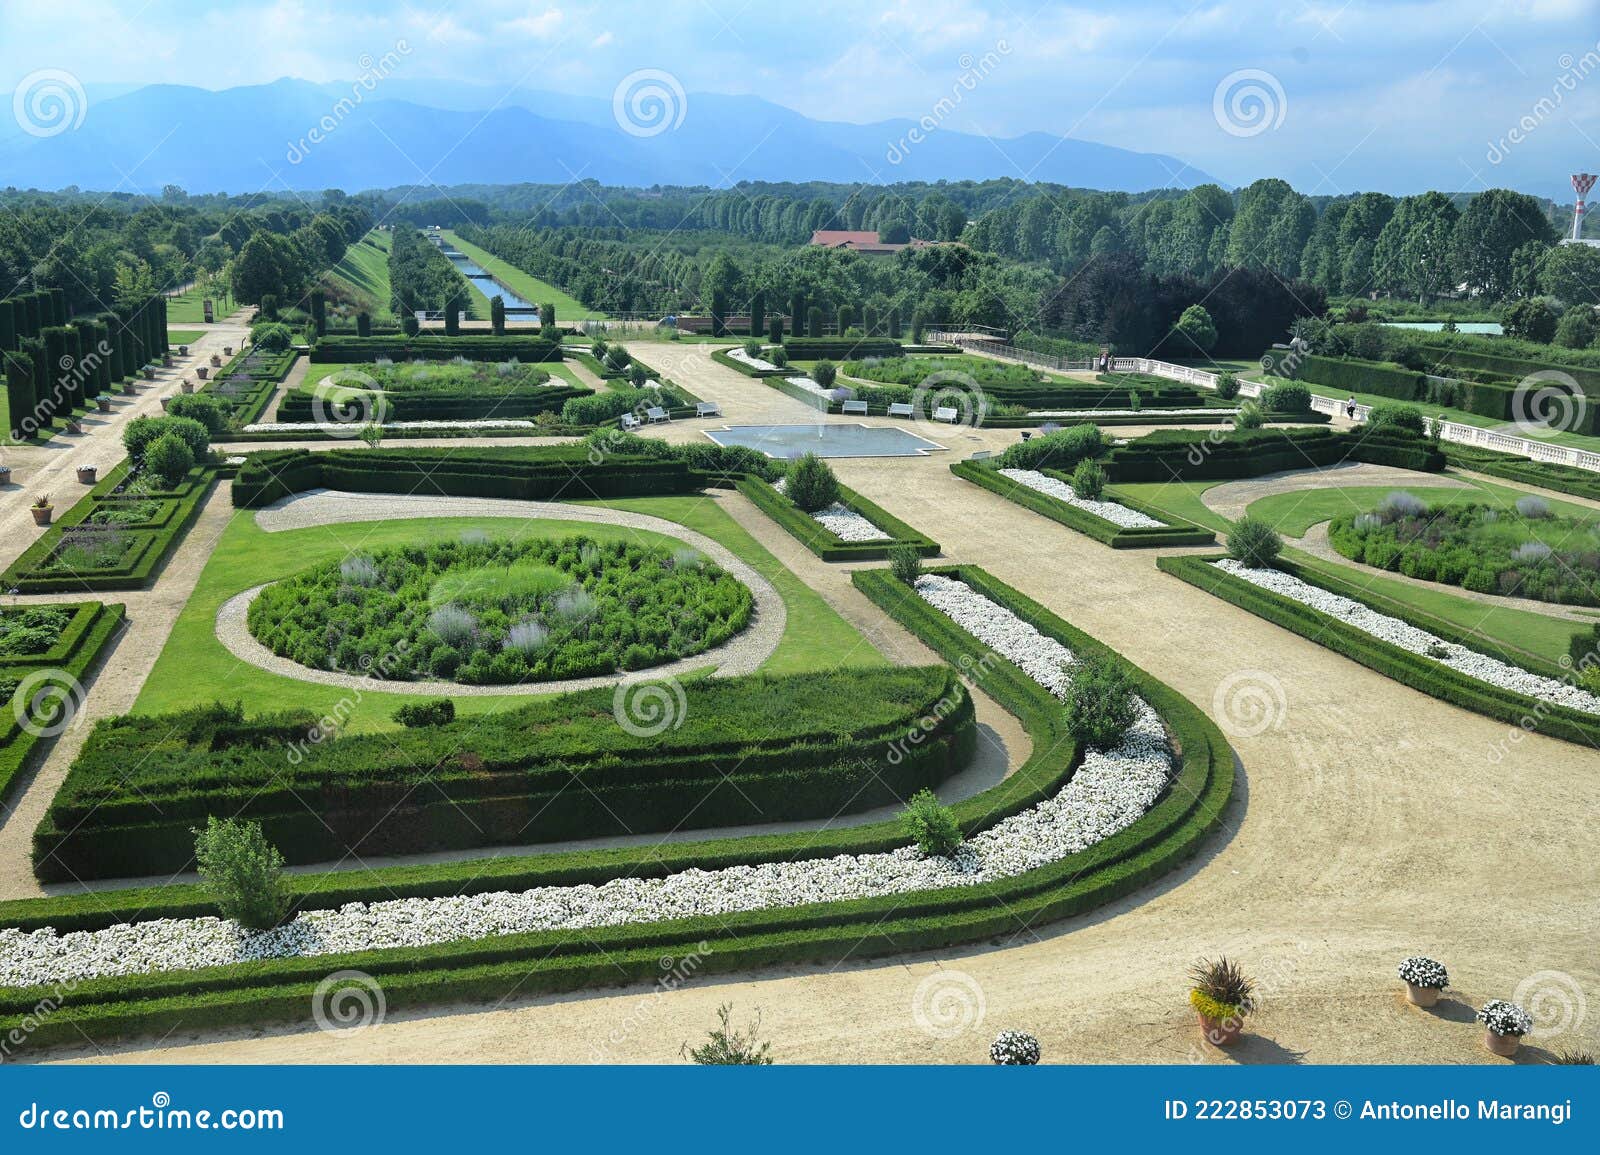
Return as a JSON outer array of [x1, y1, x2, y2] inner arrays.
[[1155, 555, 1600, 745]]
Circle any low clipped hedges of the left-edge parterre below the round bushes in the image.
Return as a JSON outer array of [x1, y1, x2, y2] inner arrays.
[[0, 461, 219, 593]]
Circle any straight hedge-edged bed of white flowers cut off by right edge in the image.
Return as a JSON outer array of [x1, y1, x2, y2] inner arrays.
[[1157, 555, 1600, 745]]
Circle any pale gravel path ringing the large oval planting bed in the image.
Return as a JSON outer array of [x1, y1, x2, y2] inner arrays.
[[216, 490, 789, 697]]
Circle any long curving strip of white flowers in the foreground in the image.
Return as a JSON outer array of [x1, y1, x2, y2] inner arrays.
[[0, 576, 1171, 987]]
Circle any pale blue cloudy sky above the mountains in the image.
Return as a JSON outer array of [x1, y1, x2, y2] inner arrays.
[[0, 0, 1600, 197]]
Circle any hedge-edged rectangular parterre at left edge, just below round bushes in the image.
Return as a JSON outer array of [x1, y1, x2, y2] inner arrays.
[[0, 462, 224, 593]]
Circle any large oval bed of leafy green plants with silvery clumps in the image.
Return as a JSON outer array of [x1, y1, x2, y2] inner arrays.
[[246, 534, 754, 686]]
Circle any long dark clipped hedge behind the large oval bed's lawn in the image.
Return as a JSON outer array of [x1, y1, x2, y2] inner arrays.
[[234, 445, 704, 509]]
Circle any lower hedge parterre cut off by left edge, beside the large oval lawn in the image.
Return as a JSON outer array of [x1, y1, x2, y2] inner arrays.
[[0, 601, 123, 801]]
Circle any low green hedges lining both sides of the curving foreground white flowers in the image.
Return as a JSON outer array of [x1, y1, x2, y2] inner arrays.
[[0, 568, 1234, 1046]]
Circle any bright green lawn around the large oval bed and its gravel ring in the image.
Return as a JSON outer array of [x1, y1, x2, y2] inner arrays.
[[134, 496, 886, 733]]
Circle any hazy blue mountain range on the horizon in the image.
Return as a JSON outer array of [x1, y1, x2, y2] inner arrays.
[[0, 78, 1213, 194]]
